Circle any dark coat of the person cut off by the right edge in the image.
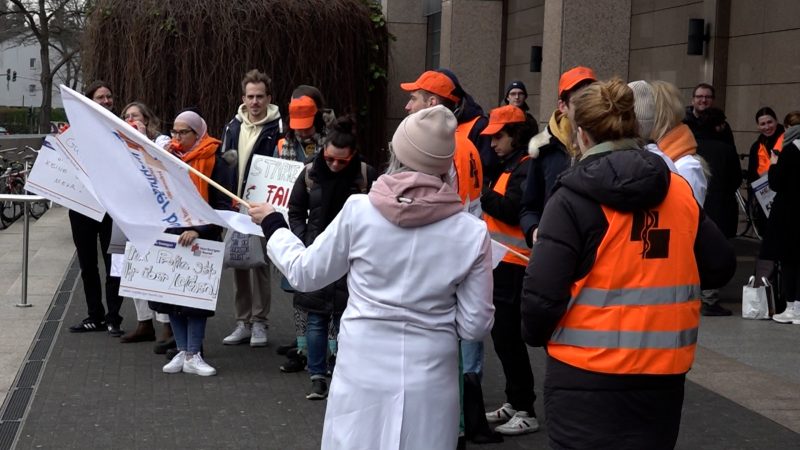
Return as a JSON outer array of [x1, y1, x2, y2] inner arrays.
[[764, 137, 800, 264]]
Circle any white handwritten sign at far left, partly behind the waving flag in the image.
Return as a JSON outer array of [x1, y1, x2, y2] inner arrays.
[[25, 130, 106, 222]]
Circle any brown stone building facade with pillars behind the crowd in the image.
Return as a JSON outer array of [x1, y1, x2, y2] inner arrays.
[[382, 0, 800, 153]]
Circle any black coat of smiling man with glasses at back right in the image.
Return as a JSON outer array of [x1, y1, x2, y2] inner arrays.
[[695, 131, 742, 238]]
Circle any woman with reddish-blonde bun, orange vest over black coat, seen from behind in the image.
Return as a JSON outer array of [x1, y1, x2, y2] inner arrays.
[[522, 79, 736, 450]]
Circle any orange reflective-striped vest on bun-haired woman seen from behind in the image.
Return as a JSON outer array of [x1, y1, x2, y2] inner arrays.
[[547, 173, 700, 375]]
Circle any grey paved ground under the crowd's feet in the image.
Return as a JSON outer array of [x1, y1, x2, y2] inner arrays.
[[0, 209, 800, 449]]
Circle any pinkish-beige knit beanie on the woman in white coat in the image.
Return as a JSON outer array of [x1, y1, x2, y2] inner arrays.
[[392, 105, 457, 176]]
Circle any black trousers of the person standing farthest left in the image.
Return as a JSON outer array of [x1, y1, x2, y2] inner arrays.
[[69, 210, 122, 326]]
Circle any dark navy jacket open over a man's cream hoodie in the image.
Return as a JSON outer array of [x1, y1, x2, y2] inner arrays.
[[209, 116, 280, 208]]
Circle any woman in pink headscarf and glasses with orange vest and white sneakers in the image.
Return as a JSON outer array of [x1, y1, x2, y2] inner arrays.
[[150, 111, 224, 377]]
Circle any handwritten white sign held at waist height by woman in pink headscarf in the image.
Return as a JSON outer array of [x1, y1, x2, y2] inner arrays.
[[119, 233, 224, 311]]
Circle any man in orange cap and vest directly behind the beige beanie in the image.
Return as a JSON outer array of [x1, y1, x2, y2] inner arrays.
[[400, 70, 483, 217]]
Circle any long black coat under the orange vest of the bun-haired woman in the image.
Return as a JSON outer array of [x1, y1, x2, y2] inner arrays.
[[521, 149, 736, 448]]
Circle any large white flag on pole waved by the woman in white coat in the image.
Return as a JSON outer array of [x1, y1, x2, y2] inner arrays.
[[61, 85, 263, 251]]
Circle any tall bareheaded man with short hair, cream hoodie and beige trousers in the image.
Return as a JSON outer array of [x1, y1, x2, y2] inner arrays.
[[215, 69, 281, 347]]
